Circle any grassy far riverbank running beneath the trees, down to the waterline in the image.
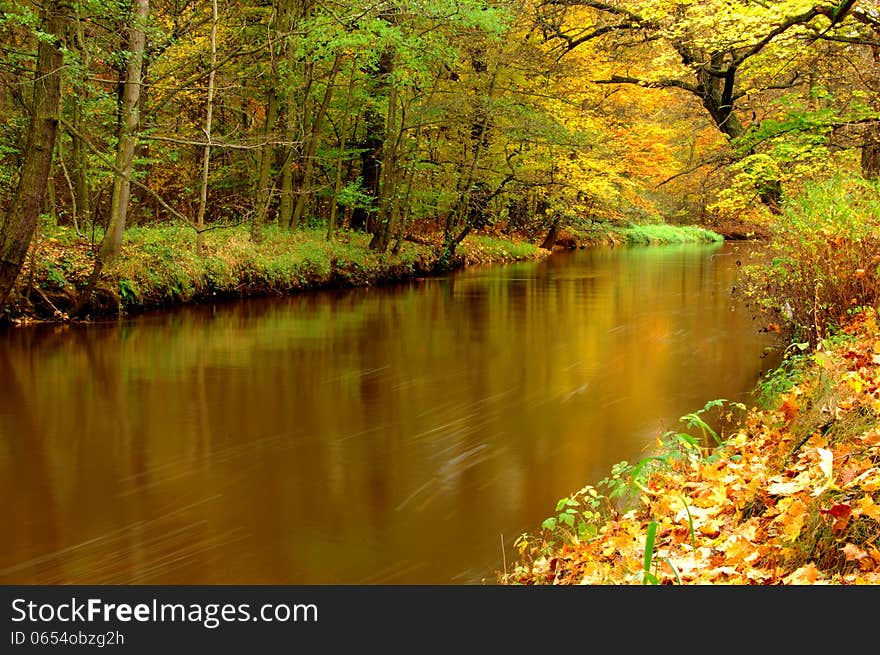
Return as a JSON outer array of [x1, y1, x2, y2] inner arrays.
[[6, 220, 722, 324]]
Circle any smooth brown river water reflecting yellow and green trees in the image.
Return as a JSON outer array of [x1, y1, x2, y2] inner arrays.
[[0, 243, 784, 584]]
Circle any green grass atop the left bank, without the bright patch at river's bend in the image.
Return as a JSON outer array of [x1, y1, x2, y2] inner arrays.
[[22, 225, 546, 320]]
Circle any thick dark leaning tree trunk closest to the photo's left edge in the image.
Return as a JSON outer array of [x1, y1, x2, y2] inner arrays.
[[0, 0, 71, 308]]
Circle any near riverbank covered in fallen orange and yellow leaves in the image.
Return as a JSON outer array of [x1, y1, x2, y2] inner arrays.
[[499, 309, 880, 585]]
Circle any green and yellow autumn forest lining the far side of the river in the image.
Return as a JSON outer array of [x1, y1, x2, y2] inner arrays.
[[0, 0, 880, 316]]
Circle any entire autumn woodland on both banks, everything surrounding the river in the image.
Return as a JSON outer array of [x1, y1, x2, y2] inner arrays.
[[0, 0, 880, 584]]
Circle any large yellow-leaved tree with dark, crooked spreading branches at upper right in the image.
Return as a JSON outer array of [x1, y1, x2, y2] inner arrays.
[[538, 0, 857, 212]]
